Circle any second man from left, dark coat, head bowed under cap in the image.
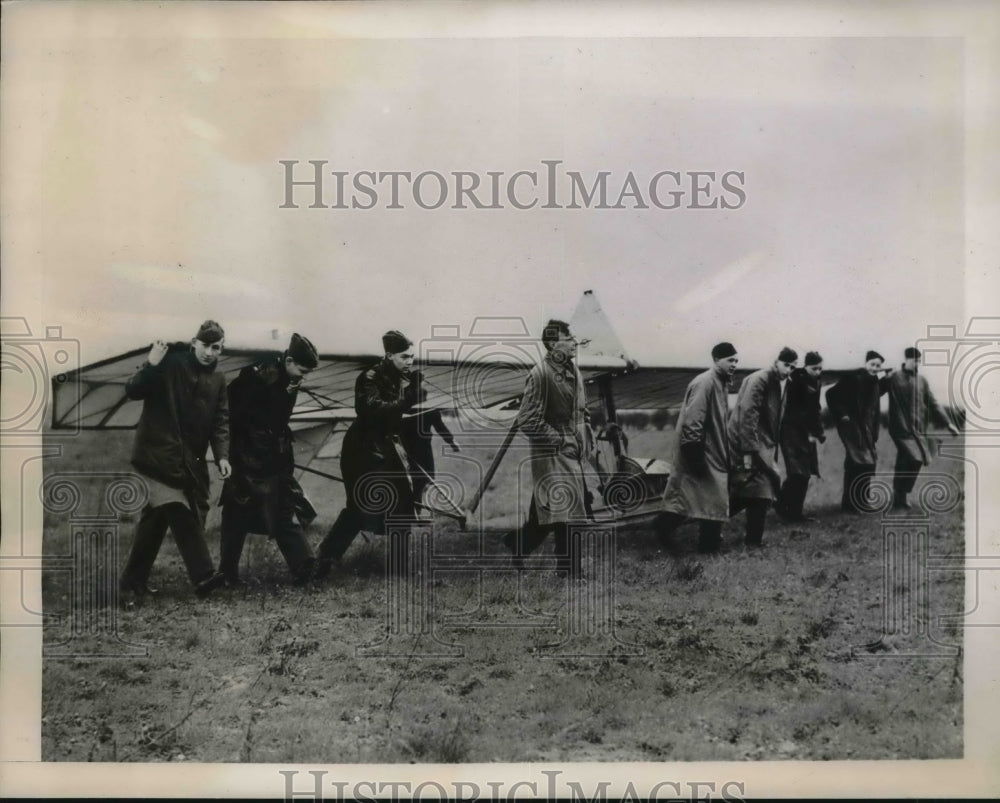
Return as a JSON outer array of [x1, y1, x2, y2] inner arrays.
[[219, 333, 319, 585]]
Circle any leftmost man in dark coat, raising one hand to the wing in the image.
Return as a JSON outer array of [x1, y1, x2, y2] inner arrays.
[[119, 321, 231, 603]]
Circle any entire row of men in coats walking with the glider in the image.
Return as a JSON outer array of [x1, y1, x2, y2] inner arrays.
[[113, 319, 957, 603]]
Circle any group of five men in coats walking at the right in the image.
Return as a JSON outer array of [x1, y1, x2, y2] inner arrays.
[[657, 343, 958, 552]]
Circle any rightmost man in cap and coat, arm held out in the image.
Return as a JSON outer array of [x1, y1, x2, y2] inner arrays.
[[889, 346, 958, 508]]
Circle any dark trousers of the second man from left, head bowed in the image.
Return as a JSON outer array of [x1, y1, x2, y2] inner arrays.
[[219, 499, 313, 582]]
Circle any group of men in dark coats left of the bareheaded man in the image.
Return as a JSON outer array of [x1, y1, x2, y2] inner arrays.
[[119, 321, 460, 604]]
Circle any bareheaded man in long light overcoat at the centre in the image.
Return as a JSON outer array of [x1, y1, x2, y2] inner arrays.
[[503, 319, 587, 578]]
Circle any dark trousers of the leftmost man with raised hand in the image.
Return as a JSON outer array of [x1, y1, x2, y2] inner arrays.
[[120, 502, 215, 588]]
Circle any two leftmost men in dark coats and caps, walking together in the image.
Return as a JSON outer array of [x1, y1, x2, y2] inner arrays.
[[119, 321, 319, 601]]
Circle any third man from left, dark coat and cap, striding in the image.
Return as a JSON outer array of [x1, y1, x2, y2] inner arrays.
[[315, 330, 420, 579]]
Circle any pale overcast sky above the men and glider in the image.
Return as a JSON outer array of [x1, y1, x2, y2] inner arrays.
[[5, 8, 964, 367]]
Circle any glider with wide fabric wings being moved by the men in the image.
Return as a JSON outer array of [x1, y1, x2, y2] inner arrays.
[[45, 290, 835, 527]]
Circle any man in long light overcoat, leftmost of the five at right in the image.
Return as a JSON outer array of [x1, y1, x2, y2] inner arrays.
[[656, 343, 739, 552]]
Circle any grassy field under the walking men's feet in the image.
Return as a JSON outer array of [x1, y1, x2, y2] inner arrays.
[[42, 428, 964, 763]]
